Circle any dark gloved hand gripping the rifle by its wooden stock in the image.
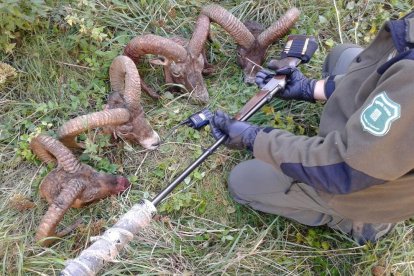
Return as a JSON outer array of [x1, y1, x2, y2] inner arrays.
[[256, 60, 317, 102]]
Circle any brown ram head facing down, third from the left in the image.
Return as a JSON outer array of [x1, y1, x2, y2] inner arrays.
[[124, 15, 210, 104]]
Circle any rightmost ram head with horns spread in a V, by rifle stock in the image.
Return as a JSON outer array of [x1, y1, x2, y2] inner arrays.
[[201, 4, 300, 84]]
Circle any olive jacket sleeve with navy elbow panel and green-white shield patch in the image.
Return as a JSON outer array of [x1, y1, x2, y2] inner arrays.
[[253, 60, 414, 194]]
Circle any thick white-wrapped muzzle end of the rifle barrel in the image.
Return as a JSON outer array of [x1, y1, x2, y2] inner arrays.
[[60, 200, 157, 276]]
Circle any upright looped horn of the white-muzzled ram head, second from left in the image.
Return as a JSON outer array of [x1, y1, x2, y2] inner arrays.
[[109, 56, 142, 111]]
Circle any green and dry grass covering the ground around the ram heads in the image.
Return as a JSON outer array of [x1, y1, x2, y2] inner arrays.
[[0, 0, 414, 275]]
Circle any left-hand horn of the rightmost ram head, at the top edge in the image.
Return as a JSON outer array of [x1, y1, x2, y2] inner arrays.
[[201, 4, 255, 48]]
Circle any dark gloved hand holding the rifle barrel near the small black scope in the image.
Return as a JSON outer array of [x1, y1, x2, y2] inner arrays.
[[210, 110, 261, 151]]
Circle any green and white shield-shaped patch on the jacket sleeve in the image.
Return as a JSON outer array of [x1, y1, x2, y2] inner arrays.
[[360, 91, 401, 136]]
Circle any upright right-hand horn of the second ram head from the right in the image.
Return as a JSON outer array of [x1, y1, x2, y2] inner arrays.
[[188, 14, 210, 57]]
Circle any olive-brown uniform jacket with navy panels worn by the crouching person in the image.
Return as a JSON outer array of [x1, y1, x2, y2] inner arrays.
[[253, 20, 414, 223]]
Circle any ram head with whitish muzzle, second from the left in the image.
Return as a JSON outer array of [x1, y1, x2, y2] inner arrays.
[[58, 56, 161, 149]]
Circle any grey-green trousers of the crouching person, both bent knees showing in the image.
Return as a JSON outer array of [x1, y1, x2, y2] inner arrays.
[[229, 44, 378, 239]]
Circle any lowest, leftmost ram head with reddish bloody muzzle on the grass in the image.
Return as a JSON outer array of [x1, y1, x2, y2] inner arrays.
[[30, 135, 130, 246]]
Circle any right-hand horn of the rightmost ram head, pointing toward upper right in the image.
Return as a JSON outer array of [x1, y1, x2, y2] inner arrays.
[[257, 8, 300, 48]]
